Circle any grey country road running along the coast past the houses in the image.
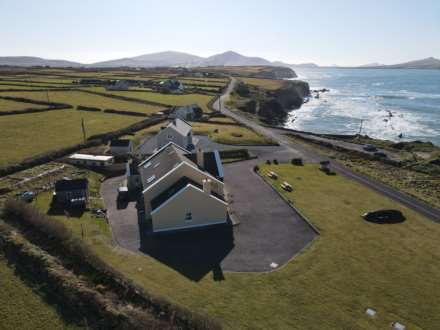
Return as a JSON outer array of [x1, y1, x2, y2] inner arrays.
[[213, 78, 440, 223]]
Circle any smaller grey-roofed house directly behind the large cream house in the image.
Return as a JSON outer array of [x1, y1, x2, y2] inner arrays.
[[156, 118, 194, 150]]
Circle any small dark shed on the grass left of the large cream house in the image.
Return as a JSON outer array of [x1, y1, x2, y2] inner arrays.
[[54, 179, 89, 206]]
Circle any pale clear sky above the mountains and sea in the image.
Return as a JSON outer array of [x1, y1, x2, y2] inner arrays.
[[0, 0, 440, 66]]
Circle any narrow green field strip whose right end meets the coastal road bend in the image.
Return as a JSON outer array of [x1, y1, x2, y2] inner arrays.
[[86, 87, 213, 112]]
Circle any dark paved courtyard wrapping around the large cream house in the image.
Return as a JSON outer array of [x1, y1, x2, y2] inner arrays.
[[101, 147, 317, 281]]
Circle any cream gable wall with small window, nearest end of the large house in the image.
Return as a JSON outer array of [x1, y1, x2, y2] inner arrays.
[[151, 185, 227, 232]]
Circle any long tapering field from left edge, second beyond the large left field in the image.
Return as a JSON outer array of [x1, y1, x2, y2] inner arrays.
[[0, 91, 162, 114]]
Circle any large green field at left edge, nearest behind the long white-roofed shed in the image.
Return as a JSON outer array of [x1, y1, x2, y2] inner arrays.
[[0, 109, 141, 166]]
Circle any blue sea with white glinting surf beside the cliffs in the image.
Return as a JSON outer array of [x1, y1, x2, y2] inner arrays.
[[285, 68, 440, 145]]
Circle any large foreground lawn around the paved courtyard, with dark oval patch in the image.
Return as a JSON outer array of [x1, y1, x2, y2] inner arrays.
[[32, 165, 440, 329]]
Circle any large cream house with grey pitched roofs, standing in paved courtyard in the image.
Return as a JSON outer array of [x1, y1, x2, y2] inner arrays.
[[138, 143, 228, 232]]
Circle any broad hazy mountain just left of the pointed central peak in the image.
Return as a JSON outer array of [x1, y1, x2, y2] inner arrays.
[[92, 51, 203, 68]]
